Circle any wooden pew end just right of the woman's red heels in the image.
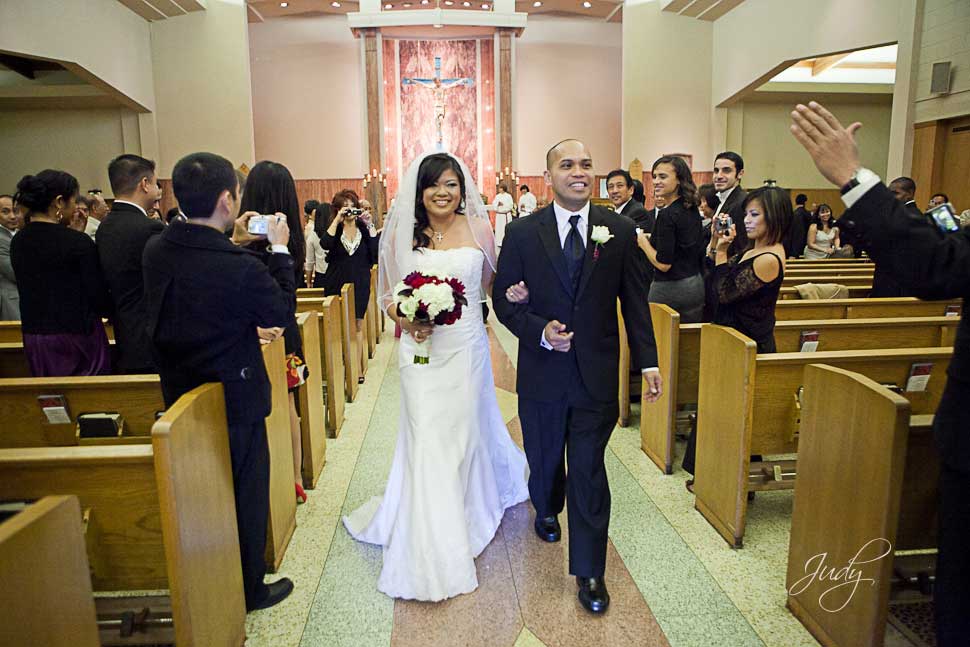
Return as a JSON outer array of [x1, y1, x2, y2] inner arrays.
[[296, 312, 327, 488]]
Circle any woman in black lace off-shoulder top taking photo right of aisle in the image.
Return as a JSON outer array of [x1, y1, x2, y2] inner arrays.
[[683, 186, 788, 492]]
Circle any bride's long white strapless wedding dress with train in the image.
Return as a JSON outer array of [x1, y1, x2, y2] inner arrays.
[[344, 247, 529, 601]]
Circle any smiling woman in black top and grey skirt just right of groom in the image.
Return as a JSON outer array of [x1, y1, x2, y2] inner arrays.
[[638, 155, 704, 323]]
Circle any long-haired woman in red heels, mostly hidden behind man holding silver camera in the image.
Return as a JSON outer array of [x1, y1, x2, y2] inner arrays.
[[239, 161, 307, 503]]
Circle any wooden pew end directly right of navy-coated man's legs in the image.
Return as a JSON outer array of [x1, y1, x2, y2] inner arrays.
[[262, 337, 296, 572]]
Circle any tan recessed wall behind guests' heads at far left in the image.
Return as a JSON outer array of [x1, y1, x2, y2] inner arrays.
[[0, 108, 139, 196]]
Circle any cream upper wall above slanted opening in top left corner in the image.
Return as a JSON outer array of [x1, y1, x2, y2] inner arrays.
[[0, 0, 155, 110]]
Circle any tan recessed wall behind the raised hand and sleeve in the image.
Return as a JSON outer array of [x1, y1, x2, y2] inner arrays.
[[732, 101, 892, 188]]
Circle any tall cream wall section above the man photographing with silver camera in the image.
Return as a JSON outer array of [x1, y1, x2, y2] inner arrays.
[[151, 0, 255, 177]]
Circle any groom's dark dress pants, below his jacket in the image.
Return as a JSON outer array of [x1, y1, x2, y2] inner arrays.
[[519, 351, 619, 577]]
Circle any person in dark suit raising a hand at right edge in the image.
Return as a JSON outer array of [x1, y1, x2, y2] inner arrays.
[[792, 103, 970, 647]]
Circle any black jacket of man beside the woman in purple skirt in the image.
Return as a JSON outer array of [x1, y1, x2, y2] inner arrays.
[[96, 202, 165, 373]]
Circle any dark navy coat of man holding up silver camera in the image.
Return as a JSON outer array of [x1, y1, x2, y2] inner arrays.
[[143, 222, 296, 427]]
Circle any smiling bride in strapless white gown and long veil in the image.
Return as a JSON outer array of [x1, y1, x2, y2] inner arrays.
[[336, 153, 529, 601]]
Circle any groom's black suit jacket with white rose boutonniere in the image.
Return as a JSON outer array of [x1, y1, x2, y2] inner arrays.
[[492, 205, 657, 402]]
